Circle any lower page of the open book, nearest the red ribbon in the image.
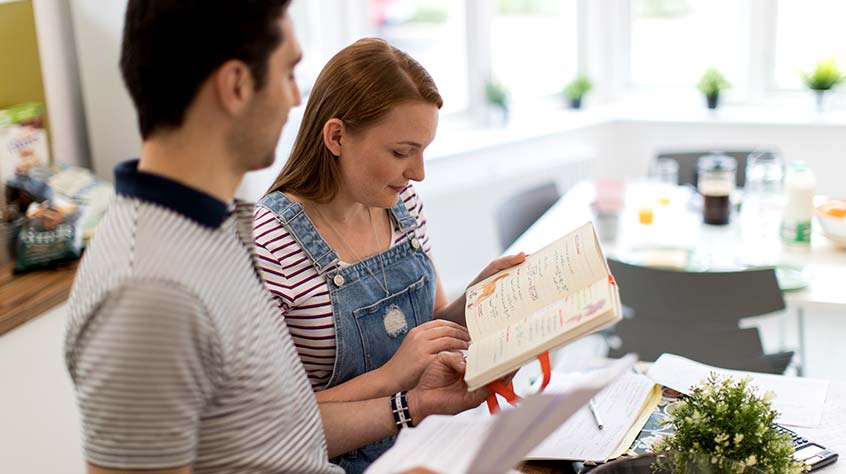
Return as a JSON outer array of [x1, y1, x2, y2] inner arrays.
[[464, 279, 617, 389]]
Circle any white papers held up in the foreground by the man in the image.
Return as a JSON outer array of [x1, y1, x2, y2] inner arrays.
[[366, 355, 635, 474]]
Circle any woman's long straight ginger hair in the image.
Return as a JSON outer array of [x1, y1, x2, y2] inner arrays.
[[267, 38, 443, 202]]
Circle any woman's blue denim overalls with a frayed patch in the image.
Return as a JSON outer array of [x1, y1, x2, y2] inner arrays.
[[258, 191, 436, 473]]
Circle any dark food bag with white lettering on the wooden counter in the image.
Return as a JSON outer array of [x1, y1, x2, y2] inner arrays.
[[14, 198, 83, 273]]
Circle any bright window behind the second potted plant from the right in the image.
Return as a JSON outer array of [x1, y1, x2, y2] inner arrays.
[[630, 0, 748, 87]]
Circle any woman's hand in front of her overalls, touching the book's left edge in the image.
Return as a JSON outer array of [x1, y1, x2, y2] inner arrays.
[[379, 319, 470, 390]]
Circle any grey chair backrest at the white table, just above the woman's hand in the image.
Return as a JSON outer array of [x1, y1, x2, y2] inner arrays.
[[496, 182, 561, 250]]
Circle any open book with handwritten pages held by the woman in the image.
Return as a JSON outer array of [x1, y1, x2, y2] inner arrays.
[[464, 223, 622, 390]]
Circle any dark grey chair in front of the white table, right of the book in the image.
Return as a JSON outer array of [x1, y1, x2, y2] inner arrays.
[[608, 259, 793, 374]]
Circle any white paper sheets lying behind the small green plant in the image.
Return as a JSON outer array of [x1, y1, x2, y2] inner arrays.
[[647, 354, 829, 427]]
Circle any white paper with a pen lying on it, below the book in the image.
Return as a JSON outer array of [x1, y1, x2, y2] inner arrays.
[[526, 373, 655, 461]]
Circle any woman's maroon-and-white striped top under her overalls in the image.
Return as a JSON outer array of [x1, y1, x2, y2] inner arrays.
[[253, 184, 431, 391]]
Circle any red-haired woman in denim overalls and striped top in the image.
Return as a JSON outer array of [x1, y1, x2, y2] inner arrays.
[[254, 39, 525, 472]]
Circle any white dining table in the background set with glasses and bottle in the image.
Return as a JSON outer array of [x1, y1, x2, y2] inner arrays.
[[505, 181, 846, 374]]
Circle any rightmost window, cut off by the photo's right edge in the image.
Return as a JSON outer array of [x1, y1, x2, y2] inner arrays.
[[774, 0, 846, 89]]
